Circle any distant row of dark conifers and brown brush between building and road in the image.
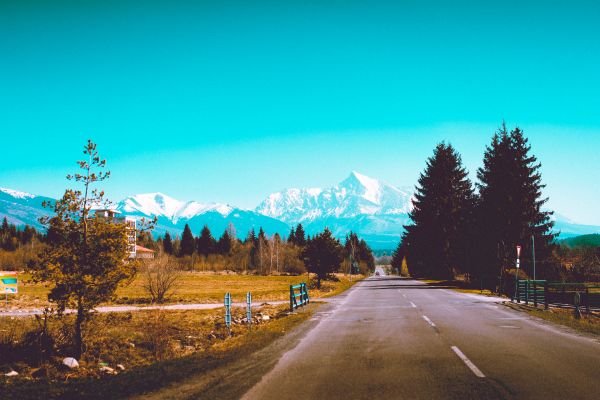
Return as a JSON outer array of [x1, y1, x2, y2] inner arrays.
[[152, 224, 375, 279]]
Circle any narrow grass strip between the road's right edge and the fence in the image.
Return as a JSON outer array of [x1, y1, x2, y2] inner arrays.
[[505, 302, 600, 335]]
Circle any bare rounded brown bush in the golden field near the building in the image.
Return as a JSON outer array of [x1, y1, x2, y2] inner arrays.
[[144, 255, 181, 303]]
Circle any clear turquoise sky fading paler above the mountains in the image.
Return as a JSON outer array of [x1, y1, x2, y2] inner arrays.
[[0, 0, 600, 224]]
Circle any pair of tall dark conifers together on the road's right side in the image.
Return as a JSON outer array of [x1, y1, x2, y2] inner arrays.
[[392, 124, 557, 290]]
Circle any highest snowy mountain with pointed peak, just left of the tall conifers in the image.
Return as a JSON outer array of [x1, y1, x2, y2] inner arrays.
[[256, 172, 412, 224]]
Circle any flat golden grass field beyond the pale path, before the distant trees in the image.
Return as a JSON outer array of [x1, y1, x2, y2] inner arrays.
[[7, 272, 364, 308]]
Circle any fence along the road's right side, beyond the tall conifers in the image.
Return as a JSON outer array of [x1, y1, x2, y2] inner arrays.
[[512, 280, 600, 313]]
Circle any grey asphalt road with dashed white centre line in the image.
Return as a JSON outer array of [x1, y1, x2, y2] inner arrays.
[[243, 276, 600, 400]]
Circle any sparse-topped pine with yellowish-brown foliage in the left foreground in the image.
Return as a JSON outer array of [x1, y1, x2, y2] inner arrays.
[[28, 140, 138, 358]]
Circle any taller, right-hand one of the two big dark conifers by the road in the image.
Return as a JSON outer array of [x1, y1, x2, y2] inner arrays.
[[472, 124, 555, 289]]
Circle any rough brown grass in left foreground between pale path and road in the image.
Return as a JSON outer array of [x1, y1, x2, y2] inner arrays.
[[0, 303, 318, 399]]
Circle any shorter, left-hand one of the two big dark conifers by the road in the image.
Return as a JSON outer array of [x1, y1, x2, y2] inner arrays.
[[402, 143, 474, 279]]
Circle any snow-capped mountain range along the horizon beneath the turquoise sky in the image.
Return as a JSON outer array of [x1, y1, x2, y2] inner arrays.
[[0, 172, 600, 249]]
